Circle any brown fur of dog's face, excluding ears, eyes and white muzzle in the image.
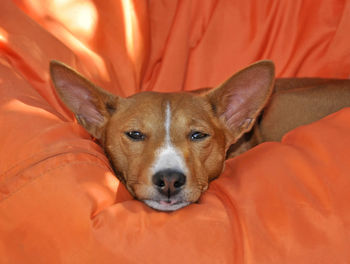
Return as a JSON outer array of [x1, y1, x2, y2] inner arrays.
[[103, 92, 225, 201]]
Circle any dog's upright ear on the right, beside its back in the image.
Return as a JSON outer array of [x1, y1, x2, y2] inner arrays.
[[205, 60, 275, 143]]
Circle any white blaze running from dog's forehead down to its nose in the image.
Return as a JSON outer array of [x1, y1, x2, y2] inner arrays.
[[152, 103, 188, 175]]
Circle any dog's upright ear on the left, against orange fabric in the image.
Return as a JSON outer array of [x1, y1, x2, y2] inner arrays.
[[50, 61, 118, 139]]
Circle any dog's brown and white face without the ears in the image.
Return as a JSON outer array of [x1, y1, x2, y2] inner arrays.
[[104, 92, 230, 210]]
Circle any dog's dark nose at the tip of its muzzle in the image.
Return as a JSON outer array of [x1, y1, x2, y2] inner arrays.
[[152, 169, 186, 197]]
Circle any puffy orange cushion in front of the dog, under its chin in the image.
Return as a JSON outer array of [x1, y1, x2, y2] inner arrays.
[[0, 56, 350, 263]]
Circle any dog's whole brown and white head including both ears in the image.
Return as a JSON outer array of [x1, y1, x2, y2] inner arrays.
[[50, 61, 274, 211]]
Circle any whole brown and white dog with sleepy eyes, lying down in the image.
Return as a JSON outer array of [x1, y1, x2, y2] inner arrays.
[[50, 60, 350, 211]]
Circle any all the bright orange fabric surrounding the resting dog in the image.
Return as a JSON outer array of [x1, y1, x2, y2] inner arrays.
[[0, 0, 350, 264]]
